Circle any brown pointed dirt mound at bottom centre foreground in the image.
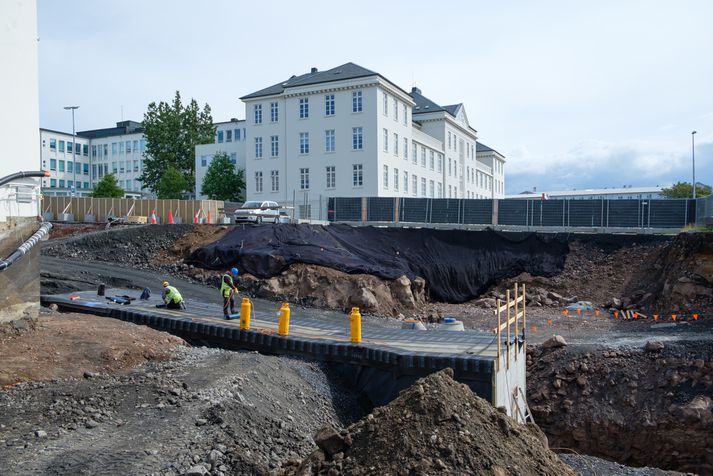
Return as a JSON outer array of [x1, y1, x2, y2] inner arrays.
[[284, 369, 576, 476]]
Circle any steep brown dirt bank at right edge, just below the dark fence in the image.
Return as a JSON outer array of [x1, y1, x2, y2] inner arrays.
[[622, 233, 713, 314]]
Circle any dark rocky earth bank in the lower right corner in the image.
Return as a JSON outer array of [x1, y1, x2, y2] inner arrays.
[[527, 342, 713, 474]]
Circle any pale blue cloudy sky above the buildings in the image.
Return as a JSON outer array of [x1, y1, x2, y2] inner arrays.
[[38, 0, 713, 194]]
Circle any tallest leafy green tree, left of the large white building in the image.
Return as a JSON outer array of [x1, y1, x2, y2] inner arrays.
[[139, 91, 215, 193]]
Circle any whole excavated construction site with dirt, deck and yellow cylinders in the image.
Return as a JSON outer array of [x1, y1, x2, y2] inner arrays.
[[0, 223, 713, 475]]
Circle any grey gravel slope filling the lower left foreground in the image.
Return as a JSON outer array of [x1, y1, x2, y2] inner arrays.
[[0, 348, 362, 475]]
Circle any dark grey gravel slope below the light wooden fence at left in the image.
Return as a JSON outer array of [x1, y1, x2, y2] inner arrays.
[[42, 225, 195, 269]]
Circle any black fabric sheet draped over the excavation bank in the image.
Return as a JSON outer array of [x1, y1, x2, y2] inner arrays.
[[188, 224, 569, 303]]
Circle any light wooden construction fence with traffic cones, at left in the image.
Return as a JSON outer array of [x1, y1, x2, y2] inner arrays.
[[42, 196, 223, 223]]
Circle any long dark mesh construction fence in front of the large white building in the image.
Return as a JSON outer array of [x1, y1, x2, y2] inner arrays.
[[327, 197, 696, 228]]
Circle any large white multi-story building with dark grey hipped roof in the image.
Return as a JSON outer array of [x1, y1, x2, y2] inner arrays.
[[236, 63, 504, 210]]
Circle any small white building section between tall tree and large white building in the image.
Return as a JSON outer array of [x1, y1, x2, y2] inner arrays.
[[196, 119, 245, 199]]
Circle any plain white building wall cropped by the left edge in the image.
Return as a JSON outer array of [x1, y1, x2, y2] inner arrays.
[[0, 0, 41, 222]]
